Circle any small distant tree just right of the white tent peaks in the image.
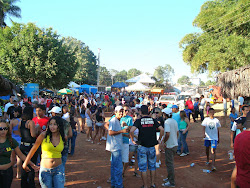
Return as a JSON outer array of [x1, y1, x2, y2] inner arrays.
[[154, 64, 174, 85]]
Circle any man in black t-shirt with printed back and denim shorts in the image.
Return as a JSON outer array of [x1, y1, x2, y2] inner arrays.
[[130, 105, 164, 188]]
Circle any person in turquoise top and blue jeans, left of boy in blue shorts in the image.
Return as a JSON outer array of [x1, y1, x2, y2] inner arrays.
[[177, 111, 190, 157]]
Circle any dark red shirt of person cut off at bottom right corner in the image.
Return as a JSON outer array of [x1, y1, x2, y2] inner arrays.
[[234, 131, 250, 188]]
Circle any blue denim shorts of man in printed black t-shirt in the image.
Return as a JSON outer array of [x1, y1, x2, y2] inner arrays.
[[137, 145, 156, 172]]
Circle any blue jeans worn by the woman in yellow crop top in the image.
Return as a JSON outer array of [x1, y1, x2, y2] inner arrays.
[[39, 164, 65, 188]]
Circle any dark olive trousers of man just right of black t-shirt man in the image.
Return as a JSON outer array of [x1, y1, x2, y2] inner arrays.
[[165, 147, 177, 185]]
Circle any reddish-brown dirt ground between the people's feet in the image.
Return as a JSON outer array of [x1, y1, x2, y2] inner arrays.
[[12, 113, 235, 188]]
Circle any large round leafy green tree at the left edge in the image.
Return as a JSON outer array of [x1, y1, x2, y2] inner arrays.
[[0, 23, 78, 89]]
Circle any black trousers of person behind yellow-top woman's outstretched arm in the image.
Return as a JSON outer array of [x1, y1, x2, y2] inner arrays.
[[20, 144, 39, 188]]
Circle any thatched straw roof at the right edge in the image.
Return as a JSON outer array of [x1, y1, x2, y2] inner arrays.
[[217, 65, 250, 99]]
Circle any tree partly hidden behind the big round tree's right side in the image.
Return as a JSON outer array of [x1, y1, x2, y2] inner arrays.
[[64, 37, 97, 85]]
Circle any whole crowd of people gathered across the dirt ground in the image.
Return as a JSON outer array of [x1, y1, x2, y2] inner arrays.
[[0, 92, 250, 188]]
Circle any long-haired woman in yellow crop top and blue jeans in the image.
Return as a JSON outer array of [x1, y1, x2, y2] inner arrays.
[[23, 116, 65, 188]]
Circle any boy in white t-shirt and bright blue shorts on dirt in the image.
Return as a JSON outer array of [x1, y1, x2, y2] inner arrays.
[[201, 108, 221, 171]]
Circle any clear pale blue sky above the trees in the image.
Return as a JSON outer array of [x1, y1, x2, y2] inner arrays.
[[8, 0, 211, 81]]
